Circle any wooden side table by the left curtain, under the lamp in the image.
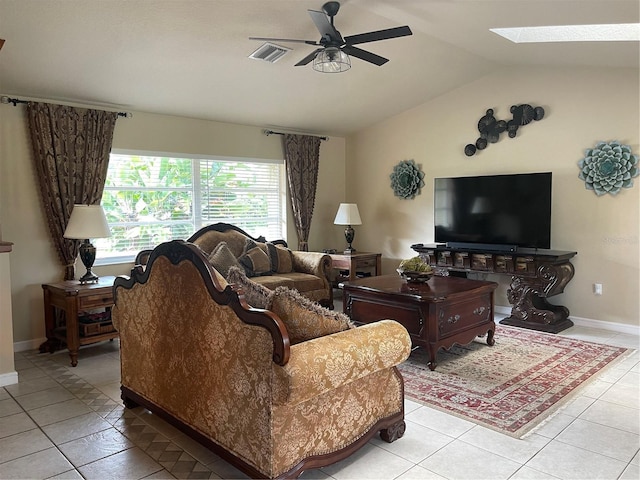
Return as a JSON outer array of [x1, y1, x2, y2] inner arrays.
[[40, 276, 118, 367]]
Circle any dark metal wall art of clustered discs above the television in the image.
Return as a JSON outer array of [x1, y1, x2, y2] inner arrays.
[[464, 103, 544, 157]]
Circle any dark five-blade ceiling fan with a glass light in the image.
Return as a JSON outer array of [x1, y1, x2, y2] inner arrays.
[[249, 2, 412, 71]]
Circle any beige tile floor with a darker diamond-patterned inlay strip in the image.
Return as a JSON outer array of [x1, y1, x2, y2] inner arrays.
[[0, 316, 640, 480]]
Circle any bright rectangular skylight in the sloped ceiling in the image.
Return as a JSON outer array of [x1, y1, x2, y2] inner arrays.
[[490, 23, 640, 43]]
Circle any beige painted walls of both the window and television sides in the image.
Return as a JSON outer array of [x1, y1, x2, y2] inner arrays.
[[0, 64, 640, 346]]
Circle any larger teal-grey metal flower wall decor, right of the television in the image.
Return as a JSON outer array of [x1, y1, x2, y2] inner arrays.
[[578, 140, 638, 196]]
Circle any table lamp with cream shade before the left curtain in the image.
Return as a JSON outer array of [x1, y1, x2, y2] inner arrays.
[[64, 205, 111, 284]]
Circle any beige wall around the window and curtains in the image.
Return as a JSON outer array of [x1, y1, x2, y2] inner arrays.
[[0, 105, 345, 348]]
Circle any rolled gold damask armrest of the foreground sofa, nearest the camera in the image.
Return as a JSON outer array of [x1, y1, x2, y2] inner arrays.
[[273, 320, 411, 405]]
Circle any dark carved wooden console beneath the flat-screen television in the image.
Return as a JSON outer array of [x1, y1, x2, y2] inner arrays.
[[411, 243, 577, 333]]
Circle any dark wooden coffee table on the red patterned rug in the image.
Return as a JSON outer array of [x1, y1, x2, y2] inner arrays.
[[342, 275, 498, 370]]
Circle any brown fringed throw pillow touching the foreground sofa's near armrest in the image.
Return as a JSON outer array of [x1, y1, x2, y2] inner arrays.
[[267, 287, 355, 345]]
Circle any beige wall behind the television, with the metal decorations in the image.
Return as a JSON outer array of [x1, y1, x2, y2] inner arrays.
[[347, 68, 640, 326]]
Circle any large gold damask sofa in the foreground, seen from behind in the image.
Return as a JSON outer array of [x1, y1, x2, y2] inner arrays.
[[112, 240, 411, 478]]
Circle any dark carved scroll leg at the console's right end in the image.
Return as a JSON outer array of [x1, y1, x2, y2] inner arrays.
[[500, 262, 574, 333]]
